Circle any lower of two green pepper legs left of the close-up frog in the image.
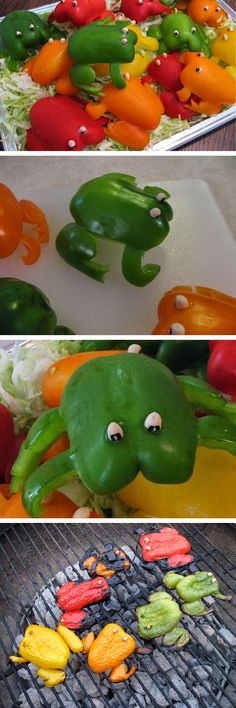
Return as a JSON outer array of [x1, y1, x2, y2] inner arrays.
[[22, 451, 78, 517]]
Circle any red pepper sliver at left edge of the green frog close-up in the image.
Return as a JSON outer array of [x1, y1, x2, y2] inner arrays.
[[0, 403, 26, 484]]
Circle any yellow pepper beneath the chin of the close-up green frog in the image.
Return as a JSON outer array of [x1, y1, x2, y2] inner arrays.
[[117, 448, 236, 518]]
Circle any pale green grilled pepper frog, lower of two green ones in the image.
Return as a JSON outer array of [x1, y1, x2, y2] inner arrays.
[[136, 591, 189, 649]]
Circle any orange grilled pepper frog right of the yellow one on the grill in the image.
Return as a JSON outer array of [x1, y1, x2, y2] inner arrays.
[[88, 624, 136, 683]]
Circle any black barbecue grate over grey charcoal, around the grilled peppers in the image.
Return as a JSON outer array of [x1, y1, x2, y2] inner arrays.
[[0, 523, 236, 708]]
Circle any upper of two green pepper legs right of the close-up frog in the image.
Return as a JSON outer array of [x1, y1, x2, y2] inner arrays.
[[177, 376, 236, 425]]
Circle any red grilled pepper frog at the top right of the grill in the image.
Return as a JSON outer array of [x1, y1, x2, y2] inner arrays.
[[139, 527, 193, 568]]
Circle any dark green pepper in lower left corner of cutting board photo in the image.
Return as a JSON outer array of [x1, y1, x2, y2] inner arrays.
[[0, 278, 74, 336]]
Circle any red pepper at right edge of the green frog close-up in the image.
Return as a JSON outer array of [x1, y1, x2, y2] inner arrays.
[[207, 340, 236, 401]]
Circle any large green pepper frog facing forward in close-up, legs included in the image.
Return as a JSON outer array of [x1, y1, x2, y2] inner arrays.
[[11, 347, 236, 516]]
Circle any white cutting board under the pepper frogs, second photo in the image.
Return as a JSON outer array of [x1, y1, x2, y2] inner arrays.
[[0, 178, 236, 335]]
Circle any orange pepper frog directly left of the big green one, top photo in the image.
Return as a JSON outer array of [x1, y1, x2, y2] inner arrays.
[[24, 39, 73, 91]]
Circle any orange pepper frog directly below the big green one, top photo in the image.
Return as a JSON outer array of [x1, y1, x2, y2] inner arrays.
[[86, 76, 164, 130]]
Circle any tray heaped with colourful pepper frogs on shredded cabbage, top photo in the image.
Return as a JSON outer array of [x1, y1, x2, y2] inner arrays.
[[0, 0, 236, 151]]
